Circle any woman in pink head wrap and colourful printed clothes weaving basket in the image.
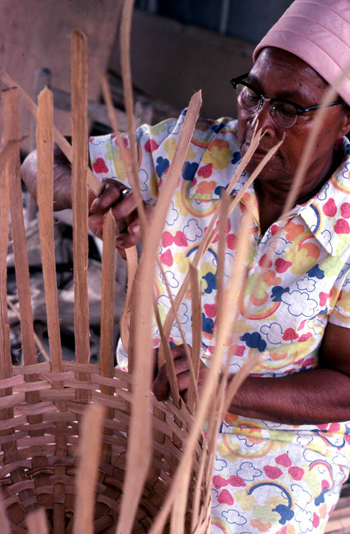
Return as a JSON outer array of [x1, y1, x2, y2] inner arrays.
[[23, 0, 350, 534]]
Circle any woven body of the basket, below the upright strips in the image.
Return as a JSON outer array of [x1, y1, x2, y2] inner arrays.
[[0, 362, 210, 533]]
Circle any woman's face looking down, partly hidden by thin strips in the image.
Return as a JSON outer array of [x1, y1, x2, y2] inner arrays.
[[238, 48, 350, 190]]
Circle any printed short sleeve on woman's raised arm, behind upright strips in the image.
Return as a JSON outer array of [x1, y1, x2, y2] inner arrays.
[[89, 109, 240, 203]]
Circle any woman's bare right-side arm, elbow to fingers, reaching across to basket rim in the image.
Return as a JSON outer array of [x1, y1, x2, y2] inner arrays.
[[154, 323, 350, 425]]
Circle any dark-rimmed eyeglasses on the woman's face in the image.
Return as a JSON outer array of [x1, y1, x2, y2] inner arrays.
[[230, 73, 344, 128]]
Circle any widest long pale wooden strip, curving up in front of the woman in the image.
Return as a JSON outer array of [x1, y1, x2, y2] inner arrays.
[[118, 89, 202, 532]]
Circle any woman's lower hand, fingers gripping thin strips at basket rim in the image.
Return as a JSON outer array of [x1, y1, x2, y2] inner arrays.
[[153, 345, 207, 401]]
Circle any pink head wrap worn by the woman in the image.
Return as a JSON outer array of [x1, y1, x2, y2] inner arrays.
[[253, 0, 350, 105]]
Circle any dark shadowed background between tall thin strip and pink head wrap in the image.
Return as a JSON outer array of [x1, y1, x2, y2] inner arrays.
[[111, 0, 291, 118]]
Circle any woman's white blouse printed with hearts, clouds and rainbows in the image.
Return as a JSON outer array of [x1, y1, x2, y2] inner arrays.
[[90, 110, 350, 441]]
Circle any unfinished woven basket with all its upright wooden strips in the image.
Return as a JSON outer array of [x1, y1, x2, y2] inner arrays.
[[0, 0, 342, 534]]
